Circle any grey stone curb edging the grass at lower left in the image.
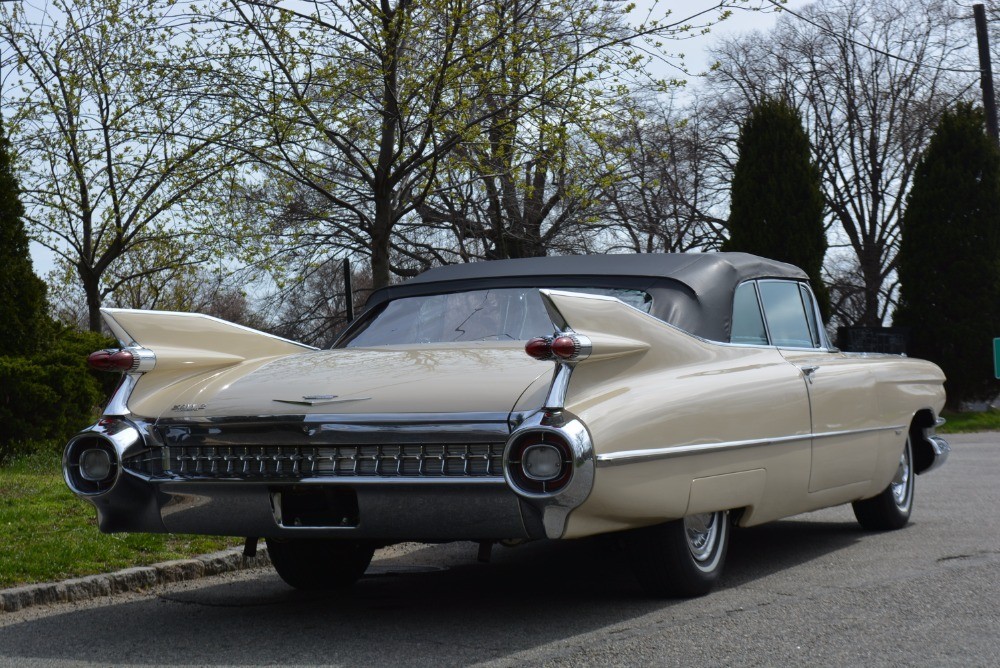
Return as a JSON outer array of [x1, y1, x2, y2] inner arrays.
[[0, 546, 271, 613]]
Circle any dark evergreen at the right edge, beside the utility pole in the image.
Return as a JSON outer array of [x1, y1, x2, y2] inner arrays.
[[894, 104, 1000, 407]]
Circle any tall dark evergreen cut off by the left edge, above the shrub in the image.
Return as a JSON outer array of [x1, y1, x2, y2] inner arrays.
[[0, 126, 50, 356]]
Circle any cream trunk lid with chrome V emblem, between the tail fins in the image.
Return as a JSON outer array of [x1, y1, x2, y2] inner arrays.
[[152, 342, 552, 417]]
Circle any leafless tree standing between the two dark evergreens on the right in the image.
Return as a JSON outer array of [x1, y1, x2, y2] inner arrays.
[[713, 0, 971, 325]]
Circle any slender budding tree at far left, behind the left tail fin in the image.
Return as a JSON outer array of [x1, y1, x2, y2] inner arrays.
[[0, 0, 242, 331]]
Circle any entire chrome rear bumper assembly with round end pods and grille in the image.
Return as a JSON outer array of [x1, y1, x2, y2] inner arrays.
[[64, 414, 593, 542]]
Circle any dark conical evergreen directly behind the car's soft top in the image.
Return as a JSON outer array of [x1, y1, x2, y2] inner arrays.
[[722, 99, 829, 318]]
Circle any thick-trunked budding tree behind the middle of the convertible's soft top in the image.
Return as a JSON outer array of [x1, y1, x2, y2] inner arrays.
[[412, 0, 627, 259]]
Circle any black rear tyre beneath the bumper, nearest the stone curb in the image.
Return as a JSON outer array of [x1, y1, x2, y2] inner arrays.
[[267, 538, 375, 590]]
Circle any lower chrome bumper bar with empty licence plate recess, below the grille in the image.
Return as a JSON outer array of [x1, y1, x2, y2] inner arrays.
[[89, 474, 545, 542]]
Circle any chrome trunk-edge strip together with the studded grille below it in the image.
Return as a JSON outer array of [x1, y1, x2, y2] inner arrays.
[[124, 412, 523, 484]]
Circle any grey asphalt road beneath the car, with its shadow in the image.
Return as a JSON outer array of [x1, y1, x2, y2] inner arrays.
[[0, 434, 1000, 668]]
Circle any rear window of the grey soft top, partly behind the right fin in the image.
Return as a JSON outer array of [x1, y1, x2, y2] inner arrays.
[[341, 288, 653, 348]]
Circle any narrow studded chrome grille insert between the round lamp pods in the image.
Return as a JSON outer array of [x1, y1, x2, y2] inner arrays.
[[124, 443, 504, 480]]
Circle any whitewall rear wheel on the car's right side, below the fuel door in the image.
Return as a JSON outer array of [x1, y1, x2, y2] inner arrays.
[[626, 511, 729, 597]]
